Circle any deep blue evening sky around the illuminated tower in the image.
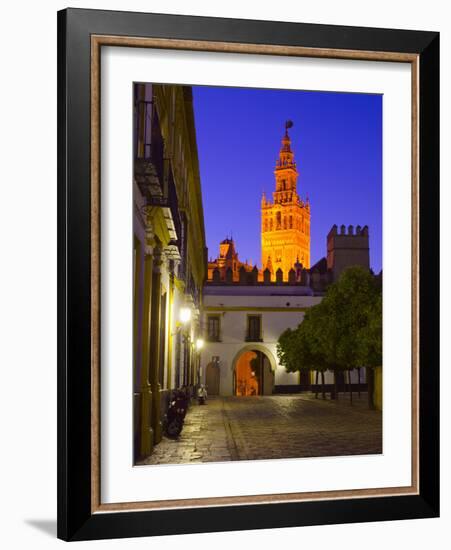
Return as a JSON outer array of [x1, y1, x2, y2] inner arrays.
[[193, 86, 382, 273]]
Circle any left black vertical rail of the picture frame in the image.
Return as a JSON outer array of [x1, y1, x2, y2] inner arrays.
[[57, 10, 91, 540]]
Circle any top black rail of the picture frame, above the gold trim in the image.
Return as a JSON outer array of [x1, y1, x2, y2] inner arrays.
[[60, 8, 436, 53]]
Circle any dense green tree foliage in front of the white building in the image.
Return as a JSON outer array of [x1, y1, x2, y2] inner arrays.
[[277, 267, 382, 384]]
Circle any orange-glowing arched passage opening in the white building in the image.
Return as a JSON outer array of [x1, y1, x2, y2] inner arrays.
[[234, 350, 274, 397]]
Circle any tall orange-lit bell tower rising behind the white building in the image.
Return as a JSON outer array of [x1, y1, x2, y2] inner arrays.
[[261, 121, 310, 281]]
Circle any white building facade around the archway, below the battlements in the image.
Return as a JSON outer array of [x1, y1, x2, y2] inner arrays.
[[199, 284, 329, 396]]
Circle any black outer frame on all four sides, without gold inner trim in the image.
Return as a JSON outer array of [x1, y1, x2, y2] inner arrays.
[[58, 9, 439, 540]]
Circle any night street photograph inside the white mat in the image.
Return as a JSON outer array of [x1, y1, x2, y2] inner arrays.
[[132, 80, 384, 467]]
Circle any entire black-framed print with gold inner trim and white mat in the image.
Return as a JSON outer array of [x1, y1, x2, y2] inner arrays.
[[58, 9, 439, 540]]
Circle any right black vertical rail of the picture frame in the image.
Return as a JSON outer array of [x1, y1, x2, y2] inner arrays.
[[419, 33, 440, 516]]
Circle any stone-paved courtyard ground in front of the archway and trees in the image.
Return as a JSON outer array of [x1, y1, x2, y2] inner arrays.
[[141, 394, 382, 464]]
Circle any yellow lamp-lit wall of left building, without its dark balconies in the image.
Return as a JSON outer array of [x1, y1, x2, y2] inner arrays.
[[134, 84, 207, 458]]
